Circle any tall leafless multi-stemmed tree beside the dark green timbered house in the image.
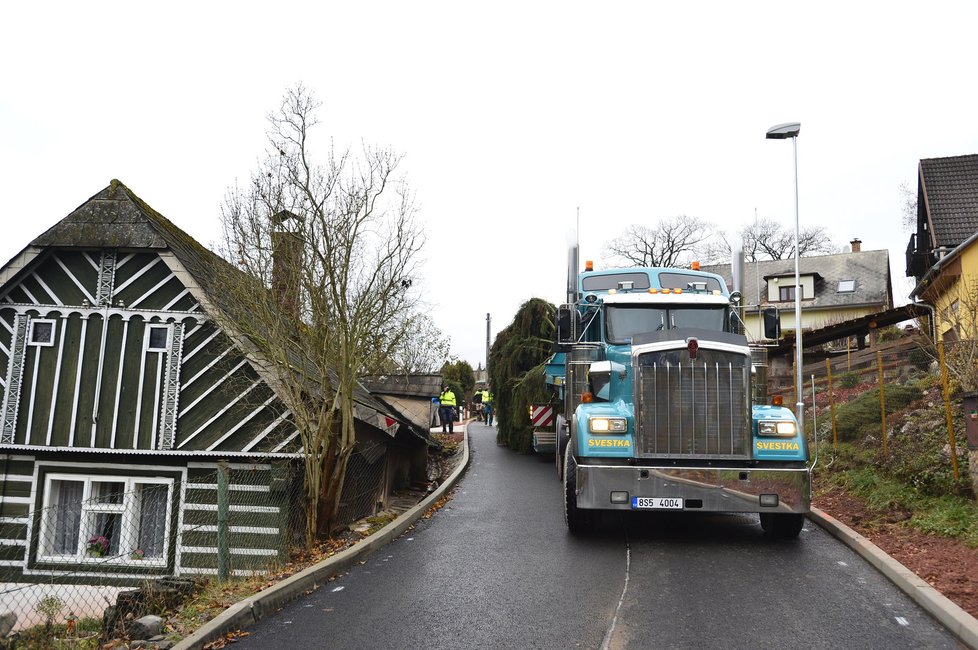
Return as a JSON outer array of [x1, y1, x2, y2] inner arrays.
[[222, 86, 423, 543]]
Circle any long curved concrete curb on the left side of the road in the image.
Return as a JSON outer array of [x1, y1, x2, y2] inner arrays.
[[173, 429, 470, 650]]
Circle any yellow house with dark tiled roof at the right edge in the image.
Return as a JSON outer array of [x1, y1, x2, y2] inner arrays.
[[907, 154, 978, 339]]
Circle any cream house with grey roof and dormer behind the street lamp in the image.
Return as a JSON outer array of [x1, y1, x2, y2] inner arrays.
[[703, 239, 893, 339]]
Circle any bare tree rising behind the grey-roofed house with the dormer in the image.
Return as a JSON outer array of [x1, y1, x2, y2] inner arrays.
[[704, 219, 839, 263]]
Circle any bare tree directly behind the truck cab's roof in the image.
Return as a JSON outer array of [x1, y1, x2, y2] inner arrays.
[[608, 215, 713, 267]]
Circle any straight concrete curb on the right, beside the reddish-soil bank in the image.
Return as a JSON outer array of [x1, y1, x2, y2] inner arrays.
[[809, 507, 978, 649]]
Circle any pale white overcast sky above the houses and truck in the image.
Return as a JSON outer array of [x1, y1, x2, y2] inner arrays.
[[0, 0, 978, 367]]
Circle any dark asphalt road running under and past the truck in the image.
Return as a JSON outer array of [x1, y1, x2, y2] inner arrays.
[[236, 424, 959, 649]]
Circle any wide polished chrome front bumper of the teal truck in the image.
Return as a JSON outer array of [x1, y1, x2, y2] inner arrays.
[[577, 465, 812, 513]]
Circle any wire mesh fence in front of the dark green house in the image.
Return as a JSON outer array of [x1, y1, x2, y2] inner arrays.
[[0, 443, 397, 648]]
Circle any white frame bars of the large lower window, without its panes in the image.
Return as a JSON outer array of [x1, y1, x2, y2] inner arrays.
[[37, 473, 174, 567]]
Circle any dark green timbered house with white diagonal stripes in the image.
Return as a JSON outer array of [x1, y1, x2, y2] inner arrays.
[[0, 181, 426, 582]]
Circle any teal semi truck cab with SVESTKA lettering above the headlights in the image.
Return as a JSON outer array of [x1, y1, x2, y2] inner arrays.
[[547, 247, 811, 539]]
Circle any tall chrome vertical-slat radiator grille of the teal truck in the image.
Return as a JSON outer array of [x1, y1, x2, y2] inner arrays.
[[635, 347, 750, 459]]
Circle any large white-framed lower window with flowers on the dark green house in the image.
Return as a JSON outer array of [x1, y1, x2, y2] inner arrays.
[[38, 474, 173, 565]]
